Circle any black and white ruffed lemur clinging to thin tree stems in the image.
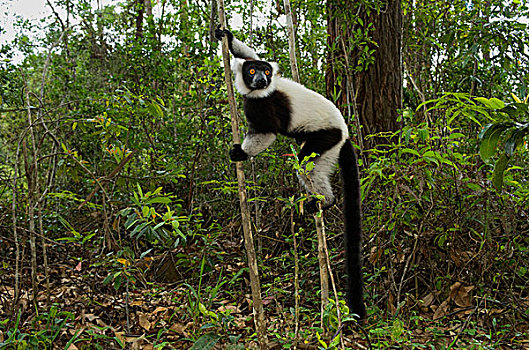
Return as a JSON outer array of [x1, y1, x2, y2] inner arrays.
[[215, 29, 366, 318]]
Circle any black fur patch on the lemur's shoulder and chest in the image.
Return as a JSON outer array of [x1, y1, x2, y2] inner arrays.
[[244, 91, 291, 135]]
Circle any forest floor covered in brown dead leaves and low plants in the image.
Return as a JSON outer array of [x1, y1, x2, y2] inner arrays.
[[0, 232, 529, 350]]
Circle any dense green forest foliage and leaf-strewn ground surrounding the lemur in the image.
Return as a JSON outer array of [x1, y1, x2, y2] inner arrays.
[[0, 0, 529, 349]]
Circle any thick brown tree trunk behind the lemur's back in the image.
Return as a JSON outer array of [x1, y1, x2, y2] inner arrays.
[[326, 0, 402, 147]]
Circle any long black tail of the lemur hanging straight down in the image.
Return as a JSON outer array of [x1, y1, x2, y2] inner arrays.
[[338, 140, 366, 319]]
